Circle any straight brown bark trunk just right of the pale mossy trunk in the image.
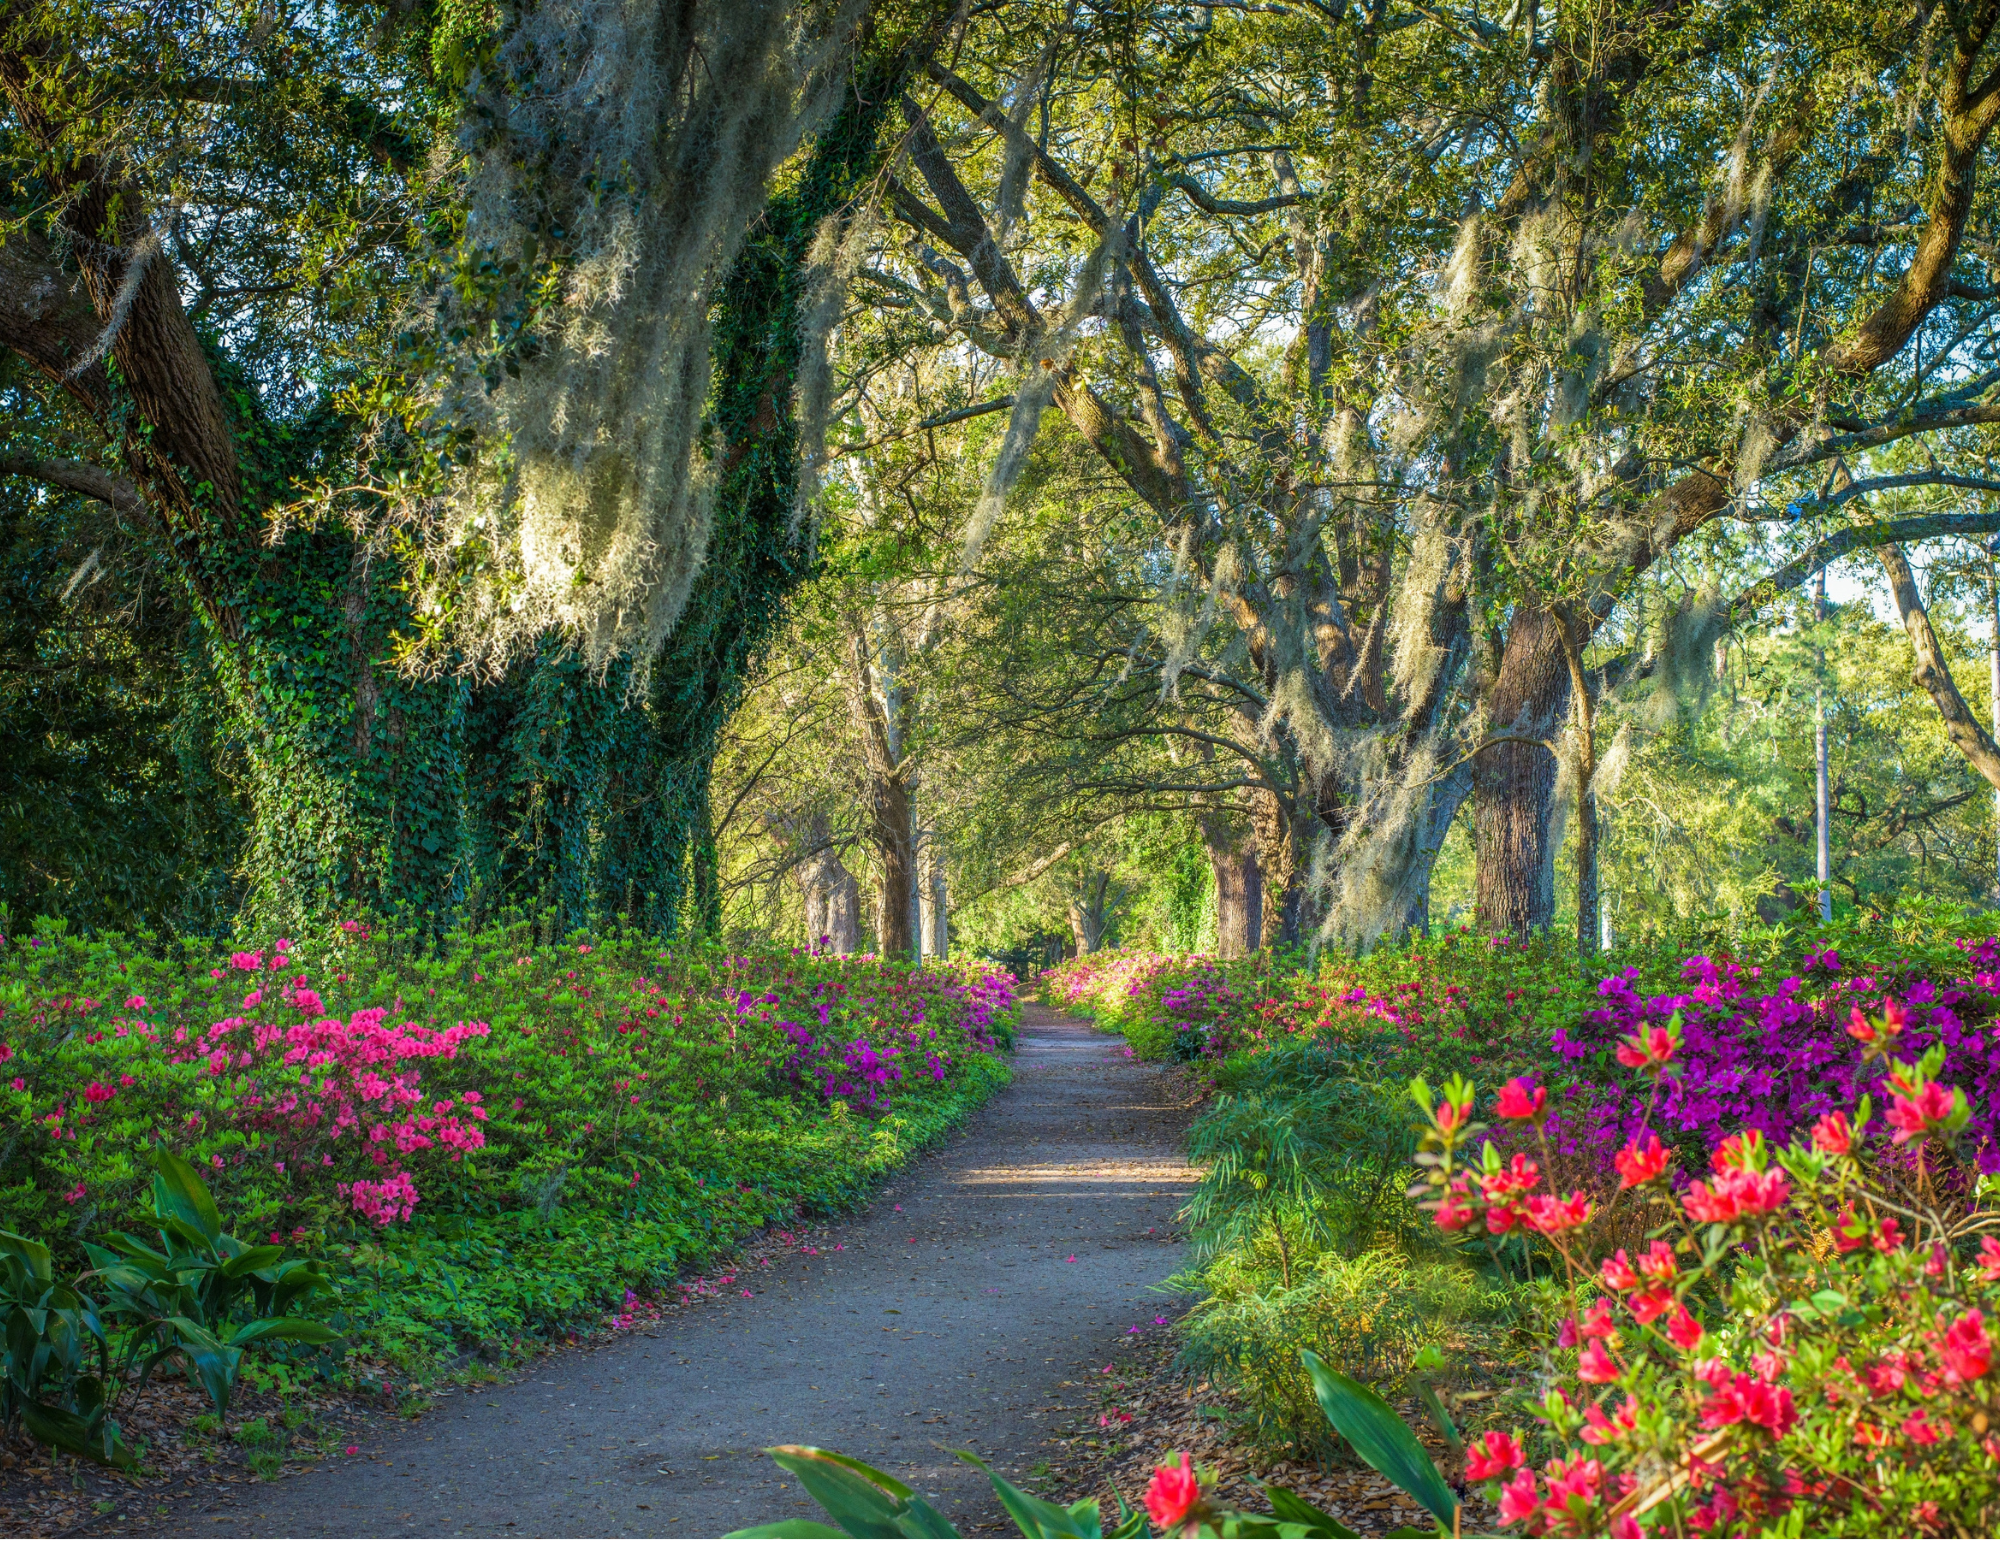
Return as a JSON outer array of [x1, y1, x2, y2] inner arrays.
[[1472, 606, 1570, 934]]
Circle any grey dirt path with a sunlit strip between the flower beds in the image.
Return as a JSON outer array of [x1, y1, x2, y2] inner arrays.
[[152, 1004, 1194, 1538]]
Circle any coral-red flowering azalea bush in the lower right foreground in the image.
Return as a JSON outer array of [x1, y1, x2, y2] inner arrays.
[[1414, 1018, 2000, 1538]]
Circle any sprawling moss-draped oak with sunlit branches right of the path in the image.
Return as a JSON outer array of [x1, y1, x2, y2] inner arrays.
[[878, 4, 2000, 936]]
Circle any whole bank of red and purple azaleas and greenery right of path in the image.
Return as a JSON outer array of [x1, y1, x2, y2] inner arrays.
[[1044, 902, 2000, 1536]]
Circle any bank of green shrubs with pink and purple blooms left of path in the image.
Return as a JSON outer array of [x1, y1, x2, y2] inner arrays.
[[0, 920, 1014, 1348]]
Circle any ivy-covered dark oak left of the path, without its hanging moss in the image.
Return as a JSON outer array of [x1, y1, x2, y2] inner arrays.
[[0, 0, 946, 926]]
